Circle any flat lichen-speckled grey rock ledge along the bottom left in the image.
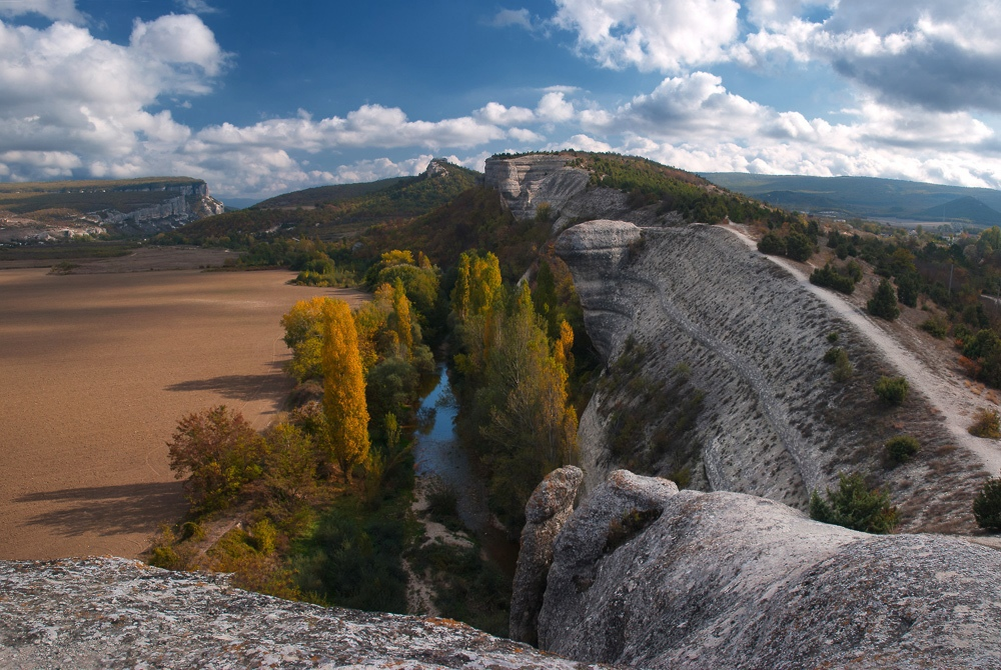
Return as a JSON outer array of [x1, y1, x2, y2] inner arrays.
[[0, 559, 608, 670]]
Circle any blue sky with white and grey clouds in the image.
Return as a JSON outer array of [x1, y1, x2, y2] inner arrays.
[[0, 0, 1001, 200]]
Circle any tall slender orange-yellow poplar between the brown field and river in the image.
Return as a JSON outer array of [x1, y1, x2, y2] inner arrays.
[[323, 300, 369, 482]]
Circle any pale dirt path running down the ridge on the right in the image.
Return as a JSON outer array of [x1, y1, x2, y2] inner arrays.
[[720, 225, 1001, 476]]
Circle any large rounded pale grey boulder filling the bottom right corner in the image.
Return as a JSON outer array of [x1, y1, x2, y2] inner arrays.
[[539, 471, 1001, 668]]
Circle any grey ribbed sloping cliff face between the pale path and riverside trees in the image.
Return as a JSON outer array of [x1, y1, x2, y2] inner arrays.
[[557, 221, 983, 532]]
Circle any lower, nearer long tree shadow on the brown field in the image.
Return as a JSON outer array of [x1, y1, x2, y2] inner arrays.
[[14, 482, 186, 536]]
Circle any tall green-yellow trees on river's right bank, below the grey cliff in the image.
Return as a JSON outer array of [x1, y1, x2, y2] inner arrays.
[[451, 251, 578, 531]]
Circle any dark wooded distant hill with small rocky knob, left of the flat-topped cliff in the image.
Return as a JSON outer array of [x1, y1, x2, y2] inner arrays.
[[177, 159, 479, 241]]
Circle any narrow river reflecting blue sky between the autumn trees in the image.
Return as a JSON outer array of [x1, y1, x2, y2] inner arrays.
[[413, 367, 518, 576]]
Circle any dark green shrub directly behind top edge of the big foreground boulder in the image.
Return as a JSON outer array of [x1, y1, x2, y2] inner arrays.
[[810, 473, 900, 533]]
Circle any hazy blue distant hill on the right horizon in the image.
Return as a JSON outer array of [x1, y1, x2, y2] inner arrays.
[[702, 172, 1001, 227]]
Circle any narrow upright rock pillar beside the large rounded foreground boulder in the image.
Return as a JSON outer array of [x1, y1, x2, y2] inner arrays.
[[509, 466, 584, 644]]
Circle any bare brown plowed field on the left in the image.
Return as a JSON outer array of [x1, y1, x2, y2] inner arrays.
[[0, 269, 364, 559]]
